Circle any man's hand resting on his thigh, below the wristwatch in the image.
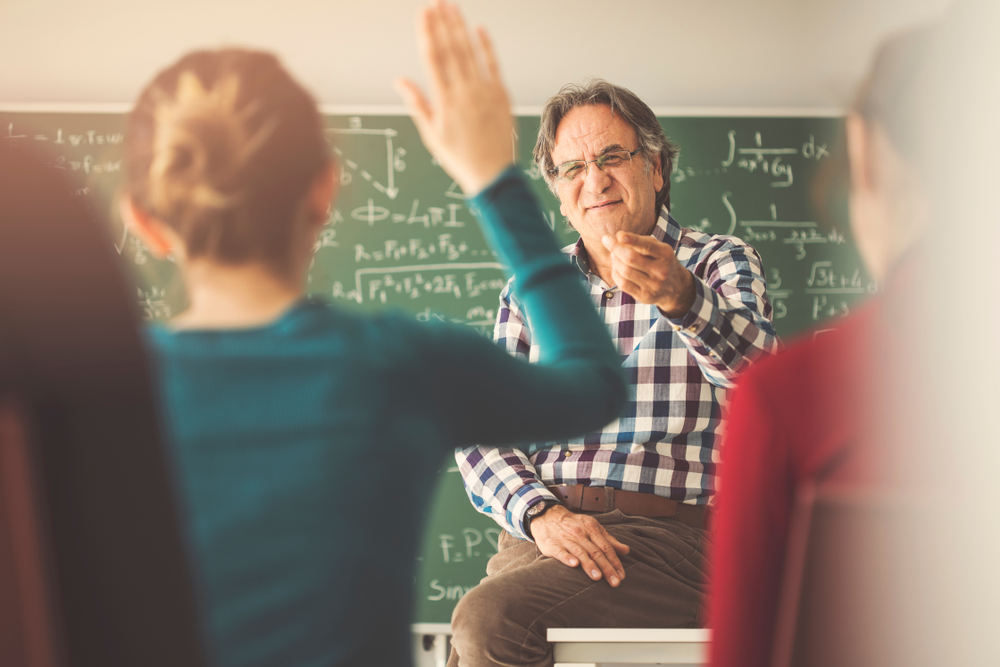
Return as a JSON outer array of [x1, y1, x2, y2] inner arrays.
[[531, 506, 629, 586]]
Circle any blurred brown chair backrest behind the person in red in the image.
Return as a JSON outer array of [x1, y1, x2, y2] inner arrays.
[[772, 486, 922, 667]]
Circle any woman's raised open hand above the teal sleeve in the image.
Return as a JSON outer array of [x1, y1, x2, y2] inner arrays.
[[396, 0, 514, 195]]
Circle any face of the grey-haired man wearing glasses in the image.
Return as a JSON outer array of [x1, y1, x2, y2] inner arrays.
[[552, 104, 663, 248]]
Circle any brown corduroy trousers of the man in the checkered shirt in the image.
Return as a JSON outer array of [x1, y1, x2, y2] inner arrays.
[[448, 510, 709, 667]]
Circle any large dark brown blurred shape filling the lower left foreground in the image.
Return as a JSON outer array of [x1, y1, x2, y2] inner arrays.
[[0, 145, 204, 667]]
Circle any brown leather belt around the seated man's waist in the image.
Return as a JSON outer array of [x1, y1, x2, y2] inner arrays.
[[548, 484, 709, 528]]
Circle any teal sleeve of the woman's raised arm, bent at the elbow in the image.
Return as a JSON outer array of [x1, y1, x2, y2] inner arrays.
[[408, 167, 626, 447]]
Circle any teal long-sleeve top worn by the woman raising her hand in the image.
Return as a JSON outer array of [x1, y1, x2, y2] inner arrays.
[[149, 168, 625, 667]]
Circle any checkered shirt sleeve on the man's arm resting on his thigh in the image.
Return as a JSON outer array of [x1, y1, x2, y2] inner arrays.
[[455, 281, 556, 540]]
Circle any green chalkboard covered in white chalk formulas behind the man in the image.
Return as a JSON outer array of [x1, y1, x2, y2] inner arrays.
[[0, 110, 875, 623]]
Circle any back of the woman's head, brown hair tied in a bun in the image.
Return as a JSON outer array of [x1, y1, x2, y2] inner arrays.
[[126, 49, 330, 269]]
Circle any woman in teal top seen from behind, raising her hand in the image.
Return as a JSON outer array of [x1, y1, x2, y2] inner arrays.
[[122, 3, 625, 666]]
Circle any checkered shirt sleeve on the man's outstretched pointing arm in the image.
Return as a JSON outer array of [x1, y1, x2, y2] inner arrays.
[[669, 237, 778, 387]]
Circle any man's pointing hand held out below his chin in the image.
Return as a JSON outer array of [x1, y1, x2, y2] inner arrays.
[[601, 232, 694, 317]]
